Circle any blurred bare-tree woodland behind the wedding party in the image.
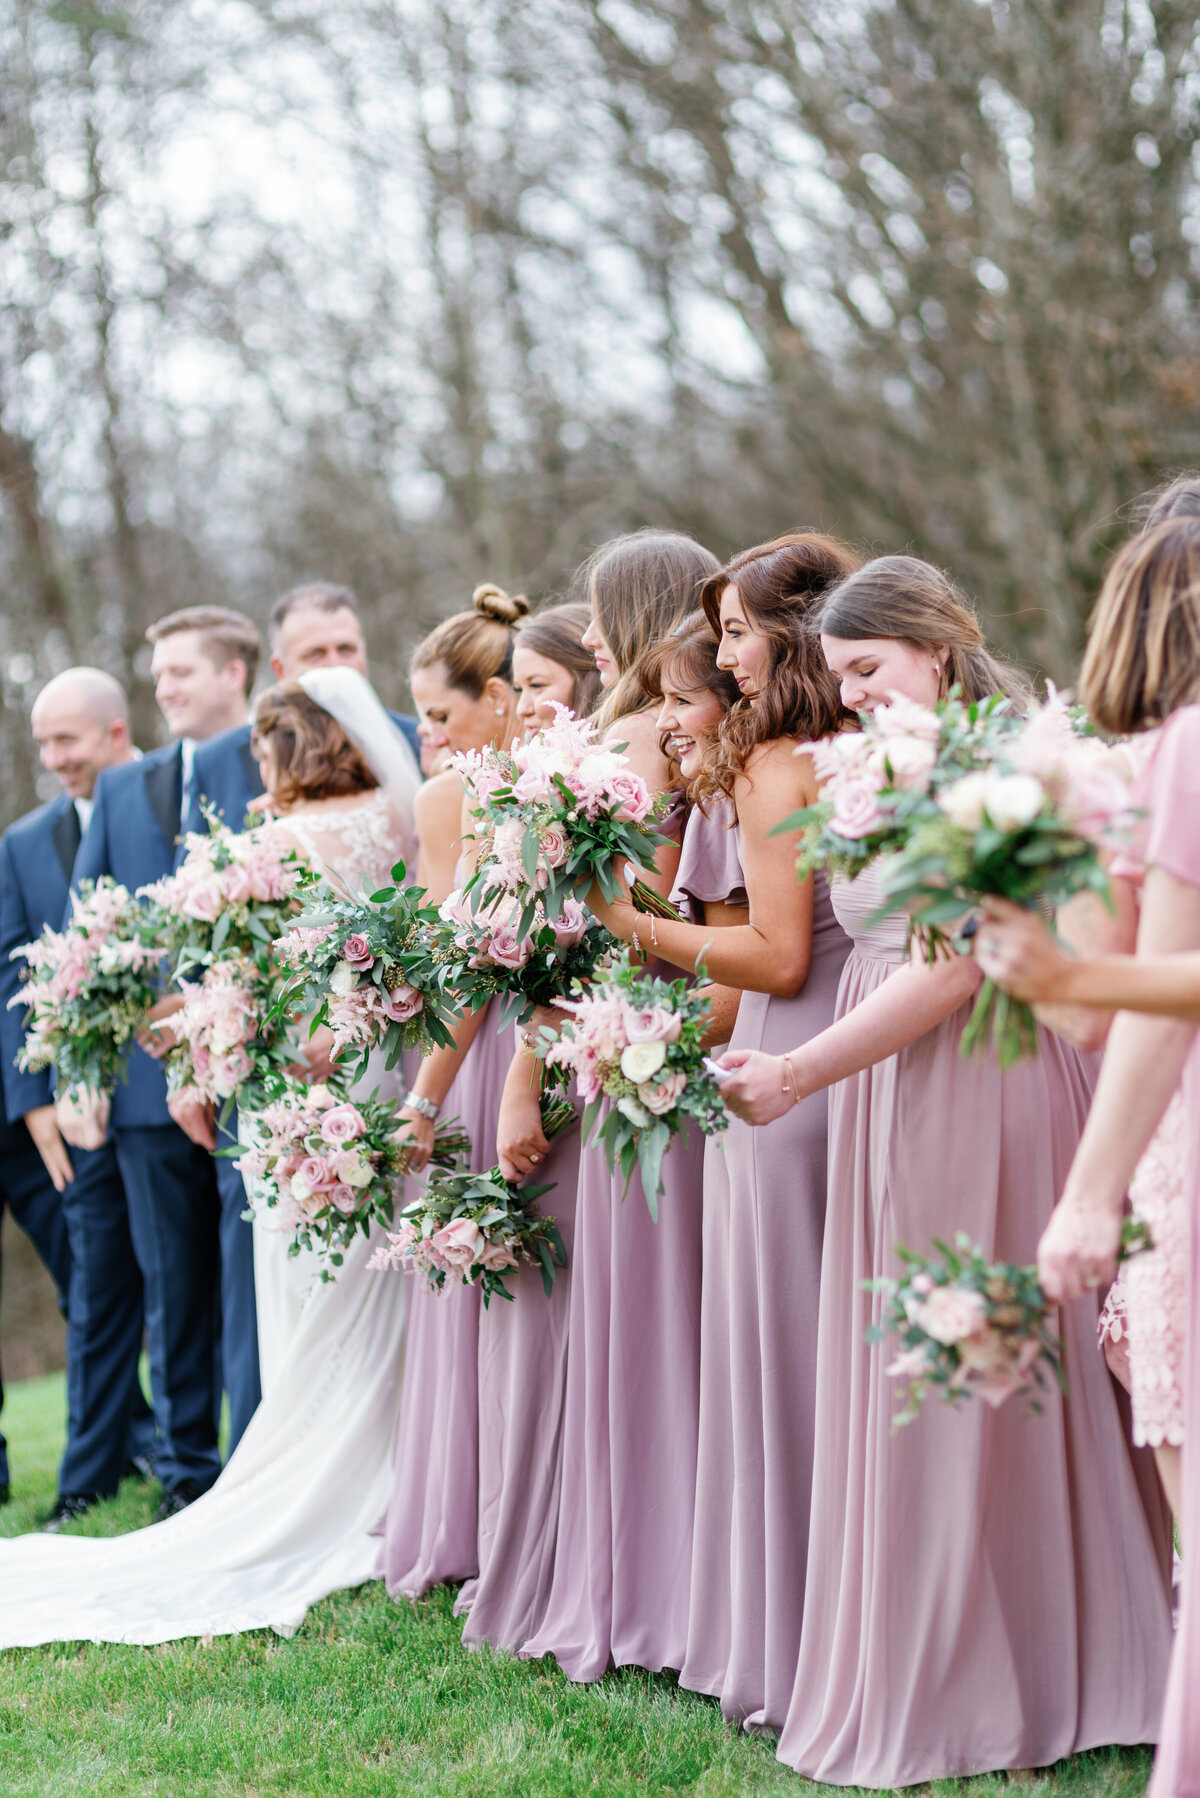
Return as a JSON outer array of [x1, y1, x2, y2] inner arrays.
[[0, 0, 1200, 1377]]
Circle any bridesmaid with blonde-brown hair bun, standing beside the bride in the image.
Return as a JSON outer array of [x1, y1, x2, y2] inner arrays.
[[380, 584, 529, 1598]]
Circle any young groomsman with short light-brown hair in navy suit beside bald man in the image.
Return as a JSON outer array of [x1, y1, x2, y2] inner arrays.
[[74, 606, 261, 1516]]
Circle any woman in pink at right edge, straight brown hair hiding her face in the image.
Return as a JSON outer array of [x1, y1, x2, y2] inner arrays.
[[975, 510, 1200, 1798]]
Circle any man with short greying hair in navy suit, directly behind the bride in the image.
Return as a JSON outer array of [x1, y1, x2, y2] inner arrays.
[[187, 581, 421, 831]]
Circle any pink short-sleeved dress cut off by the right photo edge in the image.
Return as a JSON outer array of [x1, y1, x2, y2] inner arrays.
[[1146, 705, 1200, 1798]]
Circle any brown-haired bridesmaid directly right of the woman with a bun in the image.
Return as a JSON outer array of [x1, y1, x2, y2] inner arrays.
[[457, 604, 599, 1649]]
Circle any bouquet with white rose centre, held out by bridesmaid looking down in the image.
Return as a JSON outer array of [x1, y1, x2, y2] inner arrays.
[[536, 951, 729, 1221]]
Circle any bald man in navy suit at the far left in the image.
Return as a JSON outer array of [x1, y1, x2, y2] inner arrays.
[[0, 667, 155, 1528]]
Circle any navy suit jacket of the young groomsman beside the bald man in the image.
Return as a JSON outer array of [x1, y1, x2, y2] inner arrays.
[[72, 743, 184, 1129]]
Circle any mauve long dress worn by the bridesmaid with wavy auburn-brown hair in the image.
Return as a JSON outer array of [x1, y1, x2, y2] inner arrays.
[[680, 874, 849, 1730]]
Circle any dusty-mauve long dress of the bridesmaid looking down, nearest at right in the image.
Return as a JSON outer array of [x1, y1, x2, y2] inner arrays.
[[779, 868, 1171, 1787]]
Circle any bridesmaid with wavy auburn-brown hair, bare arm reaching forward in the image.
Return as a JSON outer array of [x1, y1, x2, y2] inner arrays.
[[592, 532, 858, 1728]]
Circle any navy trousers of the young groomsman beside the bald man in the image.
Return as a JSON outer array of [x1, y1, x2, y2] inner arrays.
[[113, 1124, 221, 1491]]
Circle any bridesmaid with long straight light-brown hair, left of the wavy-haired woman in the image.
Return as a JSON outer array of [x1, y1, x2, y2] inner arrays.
[[522, 532, 718, 1679]]
